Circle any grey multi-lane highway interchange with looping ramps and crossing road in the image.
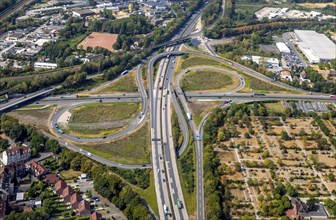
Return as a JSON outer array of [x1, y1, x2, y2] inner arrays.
[[0, 2, 335, 219]]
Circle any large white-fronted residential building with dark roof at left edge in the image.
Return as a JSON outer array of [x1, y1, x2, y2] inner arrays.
[[1, 146, 31, 165]]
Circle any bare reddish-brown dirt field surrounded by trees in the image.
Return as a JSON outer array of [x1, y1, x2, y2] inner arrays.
[[79, 32, 118, 52]]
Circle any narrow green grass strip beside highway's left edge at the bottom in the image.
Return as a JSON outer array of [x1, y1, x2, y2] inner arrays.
[[134, 171, 159, 216]]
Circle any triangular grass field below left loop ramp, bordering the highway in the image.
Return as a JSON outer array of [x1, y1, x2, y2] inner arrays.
[[80, 123, 150, 164]]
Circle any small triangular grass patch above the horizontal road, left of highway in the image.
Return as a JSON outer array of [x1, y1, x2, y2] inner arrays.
[[92, 71, 138, 94]]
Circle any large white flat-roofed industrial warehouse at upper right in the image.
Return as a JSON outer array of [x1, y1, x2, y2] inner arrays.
[[294, 30, 336, 64]]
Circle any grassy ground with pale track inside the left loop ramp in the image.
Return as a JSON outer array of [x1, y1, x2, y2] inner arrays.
[[63, 103, 141, 137]]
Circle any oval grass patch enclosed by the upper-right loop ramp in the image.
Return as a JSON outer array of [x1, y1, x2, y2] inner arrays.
[[181, 70, 238, 91]]
